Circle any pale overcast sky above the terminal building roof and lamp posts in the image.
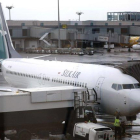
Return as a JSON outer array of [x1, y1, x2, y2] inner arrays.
[[0, 0, 140, 21]]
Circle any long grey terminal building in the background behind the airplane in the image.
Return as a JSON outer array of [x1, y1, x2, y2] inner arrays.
[[7, 12, 140, 51]]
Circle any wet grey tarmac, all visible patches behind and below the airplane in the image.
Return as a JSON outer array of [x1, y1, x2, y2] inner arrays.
[[0, 48, 140, 140]]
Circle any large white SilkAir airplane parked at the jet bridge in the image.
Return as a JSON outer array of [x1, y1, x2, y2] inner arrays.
[[0, 4, 140, 120]]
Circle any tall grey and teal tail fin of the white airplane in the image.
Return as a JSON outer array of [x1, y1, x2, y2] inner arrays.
[[0, 3, 21, 59]]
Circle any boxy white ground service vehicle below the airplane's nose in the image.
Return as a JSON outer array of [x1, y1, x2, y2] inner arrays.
[[73, 122, 115, 140]]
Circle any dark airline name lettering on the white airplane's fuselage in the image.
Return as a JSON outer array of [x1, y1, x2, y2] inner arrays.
[[61, 70, 81, 78]]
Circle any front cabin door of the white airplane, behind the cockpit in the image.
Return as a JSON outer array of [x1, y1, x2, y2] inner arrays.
[[95, 77, 105, 99]]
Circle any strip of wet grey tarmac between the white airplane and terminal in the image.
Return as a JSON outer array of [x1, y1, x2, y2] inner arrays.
[[21, 48, 140, 63]]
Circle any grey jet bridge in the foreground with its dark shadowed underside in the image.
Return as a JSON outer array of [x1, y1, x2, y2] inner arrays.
[[0, 86, 96, 138]]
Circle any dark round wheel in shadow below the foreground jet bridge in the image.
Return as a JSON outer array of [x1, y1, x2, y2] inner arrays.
[[18, 130, 31, 140]]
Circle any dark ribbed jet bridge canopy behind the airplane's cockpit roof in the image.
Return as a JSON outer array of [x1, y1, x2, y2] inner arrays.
[[115, 61, 140, 83]]
